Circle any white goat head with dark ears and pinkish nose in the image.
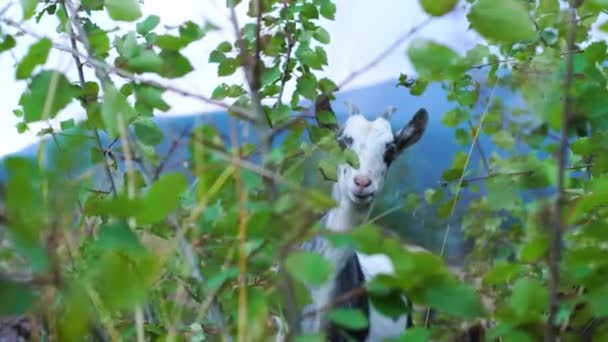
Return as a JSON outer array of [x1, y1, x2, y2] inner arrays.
[[316, 96, 428, 207]]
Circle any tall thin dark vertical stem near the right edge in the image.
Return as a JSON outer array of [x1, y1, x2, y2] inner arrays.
[[545, 0, 576, 342]]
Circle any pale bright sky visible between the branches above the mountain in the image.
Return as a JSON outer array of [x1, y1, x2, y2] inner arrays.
[[0, 0, 480, 156]]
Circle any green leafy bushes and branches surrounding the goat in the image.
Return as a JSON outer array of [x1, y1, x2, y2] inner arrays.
[[0, 0, 608, 341]]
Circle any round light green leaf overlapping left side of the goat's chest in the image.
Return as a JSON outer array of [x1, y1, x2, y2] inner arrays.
[[285, 251, 332, 286]]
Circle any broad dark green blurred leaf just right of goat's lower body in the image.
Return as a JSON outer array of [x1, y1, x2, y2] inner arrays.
[[424, 282, 484, 319]]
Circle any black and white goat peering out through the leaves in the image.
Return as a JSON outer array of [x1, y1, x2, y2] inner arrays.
[[300, 98, 428, 342]]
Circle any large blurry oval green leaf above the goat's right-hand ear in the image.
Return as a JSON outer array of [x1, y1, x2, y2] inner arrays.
[[408, 38, 469, 80]]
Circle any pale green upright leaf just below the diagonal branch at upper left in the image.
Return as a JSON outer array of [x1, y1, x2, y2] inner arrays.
[[101, 83, 137, 137]]
